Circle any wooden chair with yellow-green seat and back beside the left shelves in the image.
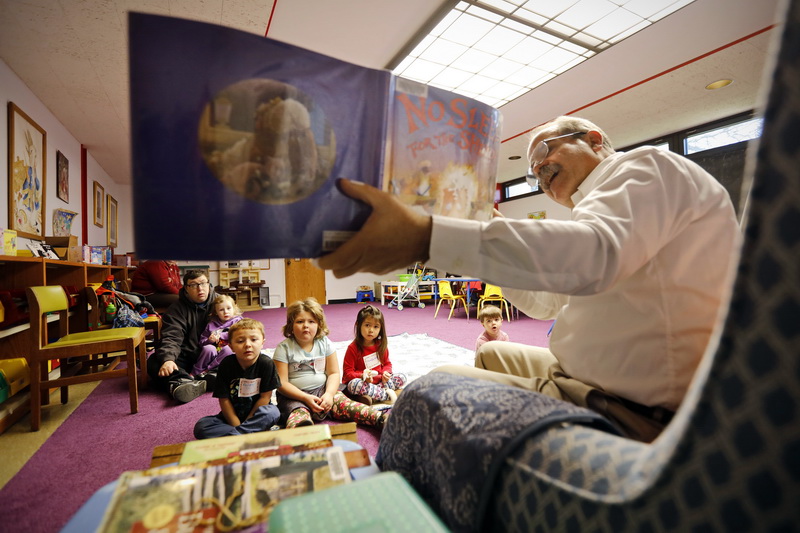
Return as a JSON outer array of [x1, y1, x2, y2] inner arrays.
[[26, 285, 147, 431]]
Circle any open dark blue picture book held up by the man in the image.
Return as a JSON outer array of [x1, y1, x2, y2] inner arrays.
[[129, 13, 501, 260]]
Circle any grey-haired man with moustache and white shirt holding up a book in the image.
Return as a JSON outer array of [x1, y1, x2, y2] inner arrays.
[[318, 117, 740, 441]]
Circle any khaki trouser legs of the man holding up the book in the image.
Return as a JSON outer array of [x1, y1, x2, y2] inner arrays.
[[433, 341, 569, 401]]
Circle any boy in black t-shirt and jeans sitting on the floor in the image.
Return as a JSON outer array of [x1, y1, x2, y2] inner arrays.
[[194, 318, 281, 439]]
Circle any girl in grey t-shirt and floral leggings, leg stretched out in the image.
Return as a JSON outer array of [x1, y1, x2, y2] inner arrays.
[[273, 298, 389, 428]]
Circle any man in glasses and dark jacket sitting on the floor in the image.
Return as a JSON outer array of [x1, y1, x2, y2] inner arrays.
[[147, 270, 216, 403]]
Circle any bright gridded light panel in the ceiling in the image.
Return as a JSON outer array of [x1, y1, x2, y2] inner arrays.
[[389, 0, 694, 107]]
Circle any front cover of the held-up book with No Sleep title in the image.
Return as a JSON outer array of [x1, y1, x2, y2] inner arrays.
[[383, 76, 500, 220]]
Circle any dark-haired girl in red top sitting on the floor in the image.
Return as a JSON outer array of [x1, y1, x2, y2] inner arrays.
[[342, 305, 406, 405]]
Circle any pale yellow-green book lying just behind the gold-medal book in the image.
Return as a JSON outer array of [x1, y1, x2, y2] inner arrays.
[[180, 424, 331, 465]]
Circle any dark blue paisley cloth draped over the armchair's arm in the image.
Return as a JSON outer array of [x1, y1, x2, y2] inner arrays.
[[375, 372, 619, 531]]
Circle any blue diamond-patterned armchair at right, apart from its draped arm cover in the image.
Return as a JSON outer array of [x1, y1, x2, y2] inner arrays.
[[484, 0, 800, 532]]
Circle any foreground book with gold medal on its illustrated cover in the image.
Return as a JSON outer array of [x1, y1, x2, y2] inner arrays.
[[100, 446, 350, 533]]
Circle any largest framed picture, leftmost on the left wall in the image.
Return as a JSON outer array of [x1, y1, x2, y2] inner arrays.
[[8, 102, 47, 240]]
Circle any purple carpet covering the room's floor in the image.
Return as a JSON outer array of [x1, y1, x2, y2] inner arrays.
[[0, 304, 550, 533]]
